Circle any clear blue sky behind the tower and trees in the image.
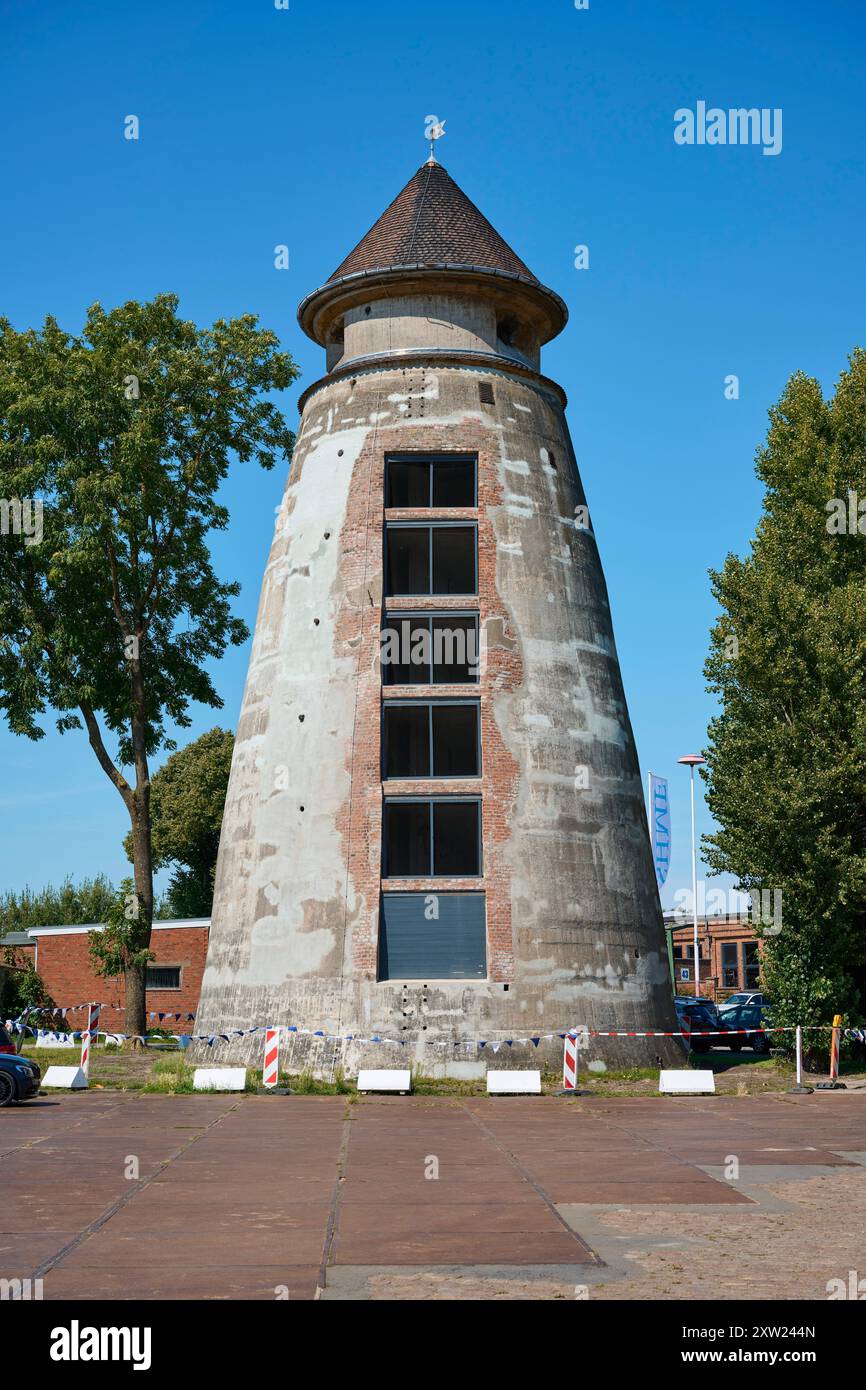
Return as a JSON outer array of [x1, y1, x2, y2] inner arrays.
[[0, 0, 866, 905]]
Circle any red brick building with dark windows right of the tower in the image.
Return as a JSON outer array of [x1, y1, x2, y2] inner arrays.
[[664, 912, 760, 999]]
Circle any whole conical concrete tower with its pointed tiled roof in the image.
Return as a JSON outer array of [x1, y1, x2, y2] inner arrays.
[[196, 158, 676, 1074]]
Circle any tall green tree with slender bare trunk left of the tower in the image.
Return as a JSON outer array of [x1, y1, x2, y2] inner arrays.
[[0, 295, 297, 1033]]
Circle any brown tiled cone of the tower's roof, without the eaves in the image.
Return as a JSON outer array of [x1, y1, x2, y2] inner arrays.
[[328, 161, 538, 284]]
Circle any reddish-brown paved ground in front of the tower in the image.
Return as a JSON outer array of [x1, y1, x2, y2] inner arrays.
[[0, 1090, 866, 1300]]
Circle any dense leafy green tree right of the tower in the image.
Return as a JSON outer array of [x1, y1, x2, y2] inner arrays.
[[703, 349, 866, 1051]]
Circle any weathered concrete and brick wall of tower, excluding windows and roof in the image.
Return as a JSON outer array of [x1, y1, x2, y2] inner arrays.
[[197, 330, 676, 1074]]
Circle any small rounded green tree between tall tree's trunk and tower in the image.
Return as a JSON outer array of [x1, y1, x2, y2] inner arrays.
[[124, 728, 235, 917]]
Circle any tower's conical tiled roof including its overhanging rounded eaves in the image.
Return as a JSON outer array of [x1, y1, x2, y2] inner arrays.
[[297, 160, 569, 358]]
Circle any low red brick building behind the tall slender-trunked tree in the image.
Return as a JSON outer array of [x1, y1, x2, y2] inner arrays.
[[4, 917, 210, 1033]]
